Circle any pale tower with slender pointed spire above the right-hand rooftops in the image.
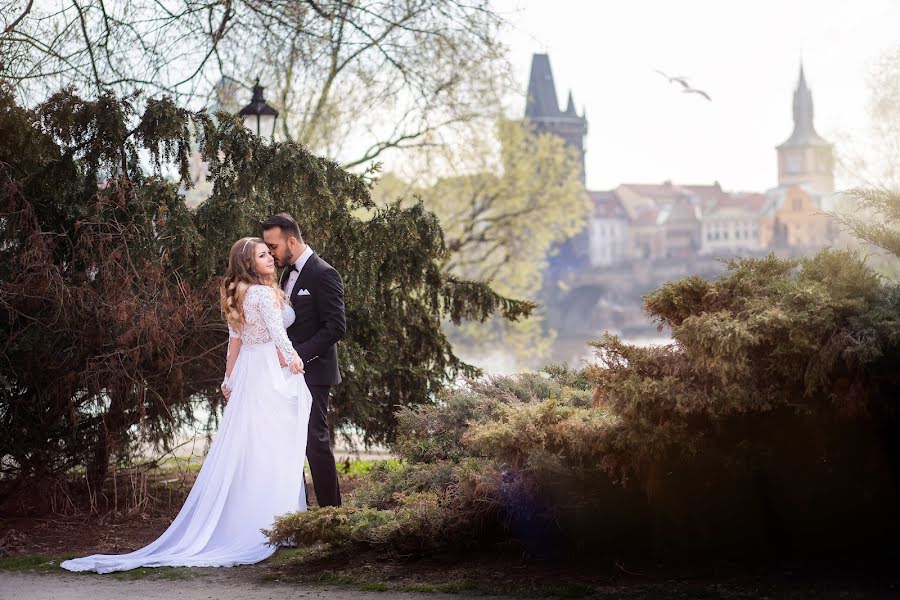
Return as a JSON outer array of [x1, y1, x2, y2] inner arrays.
[[778, 65, 834, 194]]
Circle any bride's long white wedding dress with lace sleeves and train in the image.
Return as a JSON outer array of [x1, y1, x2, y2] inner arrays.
[[60, 285, 312, 573]]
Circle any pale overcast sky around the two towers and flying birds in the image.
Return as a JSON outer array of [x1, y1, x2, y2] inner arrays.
[[498, 0, 900, 191]]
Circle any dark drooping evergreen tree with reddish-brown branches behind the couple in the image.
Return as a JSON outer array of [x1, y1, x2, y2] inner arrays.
[[0, 87, 532, 492]]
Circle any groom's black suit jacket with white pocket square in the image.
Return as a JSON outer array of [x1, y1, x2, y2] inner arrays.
[[281, 252, 347, 385]]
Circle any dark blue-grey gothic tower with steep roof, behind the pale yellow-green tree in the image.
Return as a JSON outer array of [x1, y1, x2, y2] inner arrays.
[[525, 54, 587, 181]]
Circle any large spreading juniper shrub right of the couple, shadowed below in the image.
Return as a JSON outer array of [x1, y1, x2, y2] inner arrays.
[[272, 250, 900, 556]]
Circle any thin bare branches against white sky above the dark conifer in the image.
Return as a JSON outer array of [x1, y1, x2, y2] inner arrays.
[[0, 0, 510, 167]]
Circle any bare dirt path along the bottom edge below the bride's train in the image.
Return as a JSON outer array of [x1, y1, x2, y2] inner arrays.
[[0, 569, 511, 600]]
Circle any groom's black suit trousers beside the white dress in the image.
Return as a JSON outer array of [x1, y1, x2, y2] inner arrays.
[[306, 385, 341, 506]]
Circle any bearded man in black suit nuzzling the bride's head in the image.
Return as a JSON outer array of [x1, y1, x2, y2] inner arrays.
[[262, 213, 347, 506]]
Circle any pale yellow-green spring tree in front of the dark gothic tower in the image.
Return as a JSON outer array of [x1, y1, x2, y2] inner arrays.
[[373, 120, 589, 360]]
